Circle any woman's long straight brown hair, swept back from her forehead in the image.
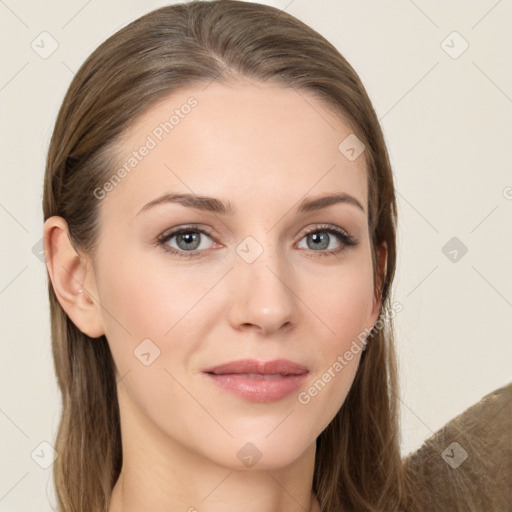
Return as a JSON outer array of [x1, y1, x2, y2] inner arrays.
[[43, 0, 404, 512]]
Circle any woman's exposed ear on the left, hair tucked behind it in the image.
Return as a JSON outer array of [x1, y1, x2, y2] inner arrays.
[[43, 216, 105, 338]]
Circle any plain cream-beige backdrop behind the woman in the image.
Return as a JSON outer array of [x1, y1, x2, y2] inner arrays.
[[0, 0, 512, 512]]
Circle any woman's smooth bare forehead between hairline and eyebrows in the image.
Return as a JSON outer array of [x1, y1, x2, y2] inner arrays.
[[102, 82, 367, 217]]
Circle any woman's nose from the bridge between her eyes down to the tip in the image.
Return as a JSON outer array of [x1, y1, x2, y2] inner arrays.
[[231, 233, 296, 333]]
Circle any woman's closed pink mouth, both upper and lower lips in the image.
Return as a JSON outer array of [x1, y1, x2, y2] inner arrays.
[[203, 359, 309, 403]]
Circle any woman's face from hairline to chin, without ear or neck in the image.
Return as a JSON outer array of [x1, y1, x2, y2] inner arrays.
[[86, 82, 380, 468]]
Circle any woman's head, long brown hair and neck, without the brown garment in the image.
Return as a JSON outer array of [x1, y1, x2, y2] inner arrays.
[[43, 0, 508, 512]]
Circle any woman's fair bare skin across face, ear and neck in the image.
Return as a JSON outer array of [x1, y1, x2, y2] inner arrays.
[[44, 83, 386, 512]]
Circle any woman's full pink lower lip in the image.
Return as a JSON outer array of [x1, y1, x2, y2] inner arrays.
[[205, 373, 308, 403]]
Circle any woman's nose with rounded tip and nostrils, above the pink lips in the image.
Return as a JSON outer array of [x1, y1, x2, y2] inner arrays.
[[229, 240, 298, 336]]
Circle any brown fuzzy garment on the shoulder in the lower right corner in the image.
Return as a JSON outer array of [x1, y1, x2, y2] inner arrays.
[[404, 383, 512, 512]]
